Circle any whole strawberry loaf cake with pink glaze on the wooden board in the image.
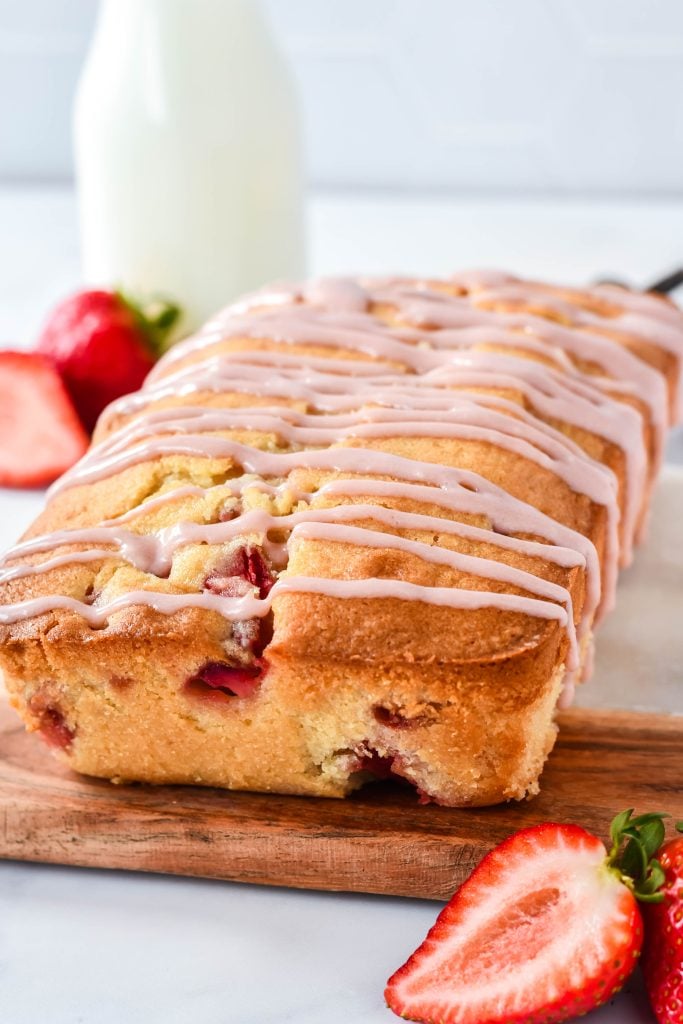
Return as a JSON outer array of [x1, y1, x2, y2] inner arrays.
[[0, 271, 683, 806]]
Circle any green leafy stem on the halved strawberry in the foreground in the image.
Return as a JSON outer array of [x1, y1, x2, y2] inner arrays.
[[607, 808, 671, 903]]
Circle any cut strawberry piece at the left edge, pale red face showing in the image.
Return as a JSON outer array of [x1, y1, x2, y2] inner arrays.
[[0, 351, 88, 487]]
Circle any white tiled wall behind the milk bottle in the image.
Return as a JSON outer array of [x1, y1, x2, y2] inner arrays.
[[0, 0, 683, 195]]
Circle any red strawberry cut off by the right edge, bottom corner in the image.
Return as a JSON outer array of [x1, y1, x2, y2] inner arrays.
[[643, 821, 683, 1024]]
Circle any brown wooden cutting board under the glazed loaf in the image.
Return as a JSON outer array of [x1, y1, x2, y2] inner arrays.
[[0, 701, 683, 899]]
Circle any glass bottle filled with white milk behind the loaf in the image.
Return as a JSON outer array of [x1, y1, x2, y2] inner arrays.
[[75, 0, 304, 330]]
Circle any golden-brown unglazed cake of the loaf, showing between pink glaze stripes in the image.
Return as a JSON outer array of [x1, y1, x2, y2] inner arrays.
[[0, 272, 678, 805]]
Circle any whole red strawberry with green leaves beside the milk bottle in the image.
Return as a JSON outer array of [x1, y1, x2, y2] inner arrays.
[[37, 291, 179, 431]]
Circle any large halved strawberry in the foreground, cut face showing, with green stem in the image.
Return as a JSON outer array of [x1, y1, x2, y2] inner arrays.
[[385, 811, 664, 1024]]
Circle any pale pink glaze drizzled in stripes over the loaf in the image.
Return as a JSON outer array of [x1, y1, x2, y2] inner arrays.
[[0, 271, 683, 708]]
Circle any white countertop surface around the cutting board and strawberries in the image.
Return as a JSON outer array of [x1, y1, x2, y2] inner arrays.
[[0, 188, 683, 1024]]
